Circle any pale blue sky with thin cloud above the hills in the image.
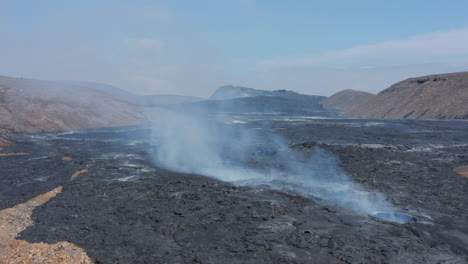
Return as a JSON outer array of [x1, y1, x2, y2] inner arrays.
[[0, 0, 468, 97]]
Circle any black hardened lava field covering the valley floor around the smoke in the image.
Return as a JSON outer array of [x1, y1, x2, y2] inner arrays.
[[0, 113, 468, 263]]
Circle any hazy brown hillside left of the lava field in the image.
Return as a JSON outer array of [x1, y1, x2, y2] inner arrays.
[[0, 76, 145, 140]]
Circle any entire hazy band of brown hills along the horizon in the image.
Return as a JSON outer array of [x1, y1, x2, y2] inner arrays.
[[0, 72, 468, 147]]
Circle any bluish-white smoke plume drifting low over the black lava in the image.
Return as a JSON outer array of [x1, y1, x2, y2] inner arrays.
[[151, 107, 395, 217]]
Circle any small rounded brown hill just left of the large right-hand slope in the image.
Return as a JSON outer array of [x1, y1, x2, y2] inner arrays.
[[321, 89, 374, 111]]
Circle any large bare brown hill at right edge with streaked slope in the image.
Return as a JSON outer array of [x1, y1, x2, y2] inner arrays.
[[345, 72, 468, 119]]
